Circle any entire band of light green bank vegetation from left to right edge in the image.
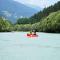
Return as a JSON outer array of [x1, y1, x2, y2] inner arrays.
[[0, 11, 60, 33]]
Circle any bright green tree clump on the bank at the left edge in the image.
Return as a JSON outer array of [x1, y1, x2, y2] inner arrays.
[[0, 17, 12, 32]]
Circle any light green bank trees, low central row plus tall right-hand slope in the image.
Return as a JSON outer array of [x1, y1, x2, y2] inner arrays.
[[15, 11, 60, 33]]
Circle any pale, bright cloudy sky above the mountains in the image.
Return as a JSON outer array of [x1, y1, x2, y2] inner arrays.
[[14, 0, 60, 8]]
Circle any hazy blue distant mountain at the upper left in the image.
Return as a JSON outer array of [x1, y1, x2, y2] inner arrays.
[[0, 0, 37, 22]]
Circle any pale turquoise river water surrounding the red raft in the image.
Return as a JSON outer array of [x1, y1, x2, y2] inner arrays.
[[0, 32, 60, 60]]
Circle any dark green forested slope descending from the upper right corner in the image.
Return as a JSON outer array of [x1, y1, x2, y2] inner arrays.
[[30, 1, 60, 23]]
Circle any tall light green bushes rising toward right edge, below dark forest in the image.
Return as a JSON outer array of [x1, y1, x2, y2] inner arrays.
[[33, 11, 60, 33]]
